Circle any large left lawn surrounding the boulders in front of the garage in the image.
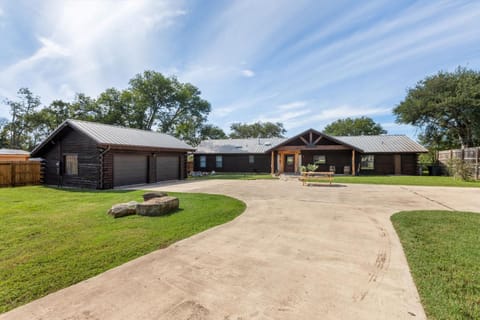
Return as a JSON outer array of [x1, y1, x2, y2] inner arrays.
[[0, 187, 245, 312]]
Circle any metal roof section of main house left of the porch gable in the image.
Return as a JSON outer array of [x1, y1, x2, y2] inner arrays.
[[195, 138, 287, 153]]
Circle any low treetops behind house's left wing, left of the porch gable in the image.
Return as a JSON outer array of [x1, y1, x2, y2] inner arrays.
[[230, 122, 287, 139]]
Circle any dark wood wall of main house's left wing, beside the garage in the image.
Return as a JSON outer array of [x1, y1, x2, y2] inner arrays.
[[193, 153, 270, 172]]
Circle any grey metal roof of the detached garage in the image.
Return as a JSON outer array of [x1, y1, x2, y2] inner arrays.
[[32, 120, 195, 154]]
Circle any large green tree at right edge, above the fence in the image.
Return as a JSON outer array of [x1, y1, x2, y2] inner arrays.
[[393, 67, 480, 150]]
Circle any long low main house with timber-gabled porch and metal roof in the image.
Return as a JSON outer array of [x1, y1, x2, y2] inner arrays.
[[194, 129, 427, 175]]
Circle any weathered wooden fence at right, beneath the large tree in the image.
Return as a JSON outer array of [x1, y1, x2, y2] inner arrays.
[[438, 147, 480, 180]]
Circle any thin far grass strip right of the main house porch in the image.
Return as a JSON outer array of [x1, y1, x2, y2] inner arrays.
[[334, 176, 480, 188]]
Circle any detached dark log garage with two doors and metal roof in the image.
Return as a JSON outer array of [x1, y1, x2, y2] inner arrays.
[[32, 120, 194, 189]]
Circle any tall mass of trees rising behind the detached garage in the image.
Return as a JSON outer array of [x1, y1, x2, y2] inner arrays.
[[0, 70, 214, 150]]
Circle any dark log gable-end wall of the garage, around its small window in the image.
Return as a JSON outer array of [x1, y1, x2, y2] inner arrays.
[[38, 127, 100, 189]]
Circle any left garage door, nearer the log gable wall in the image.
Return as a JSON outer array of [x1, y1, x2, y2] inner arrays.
[[113, 154, 147, 187]]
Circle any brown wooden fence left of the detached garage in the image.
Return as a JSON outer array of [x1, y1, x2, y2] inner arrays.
[[0, 161, 42, 187]]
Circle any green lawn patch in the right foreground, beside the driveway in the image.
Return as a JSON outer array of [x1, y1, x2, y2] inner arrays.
[[392, 211, 480, 319]]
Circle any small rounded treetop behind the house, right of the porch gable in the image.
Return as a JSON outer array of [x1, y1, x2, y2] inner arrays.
[[323, 117, 387, 136]]
